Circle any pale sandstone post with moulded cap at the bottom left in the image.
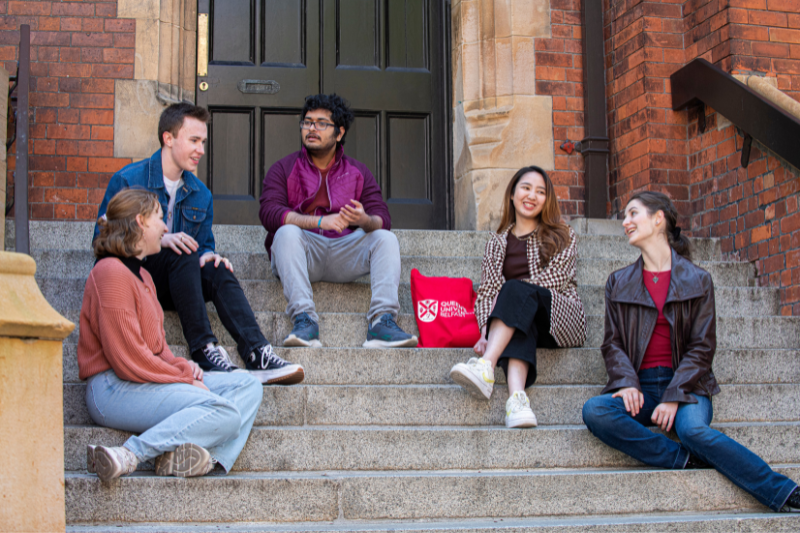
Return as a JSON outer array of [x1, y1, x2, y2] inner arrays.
[[0, 252, 75, 532]]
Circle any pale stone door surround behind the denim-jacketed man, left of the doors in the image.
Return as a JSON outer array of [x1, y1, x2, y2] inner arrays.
[[114, 0, 197, 160]]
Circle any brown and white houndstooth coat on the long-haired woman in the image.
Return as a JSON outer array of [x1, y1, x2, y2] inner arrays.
[[475, 224, 586, 348]]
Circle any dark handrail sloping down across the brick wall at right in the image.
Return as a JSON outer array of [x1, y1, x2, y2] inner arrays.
[[670, 59, 800, 168]]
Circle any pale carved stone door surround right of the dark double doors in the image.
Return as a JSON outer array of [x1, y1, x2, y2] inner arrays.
[[452, 0, 555, 230]]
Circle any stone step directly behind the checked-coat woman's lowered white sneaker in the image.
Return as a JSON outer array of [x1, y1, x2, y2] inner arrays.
[[64, 383, 800, 426]]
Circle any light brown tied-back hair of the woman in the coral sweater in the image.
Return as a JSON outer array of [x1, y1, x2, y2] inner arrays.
[[92, 189, 159, 259]]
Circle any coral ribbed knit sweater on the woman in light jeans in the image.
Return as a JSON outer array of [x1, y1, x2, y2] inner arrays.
[[78, 257, 194, 384]]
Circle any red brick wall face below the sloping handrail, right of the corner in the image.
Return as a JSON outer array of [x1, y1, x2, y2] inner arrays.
[[689, 112, 800, 315]]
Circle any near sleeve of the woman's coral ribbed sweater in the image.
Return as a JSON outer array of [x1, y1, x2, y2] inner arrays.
[[97, 307, 194, 384]]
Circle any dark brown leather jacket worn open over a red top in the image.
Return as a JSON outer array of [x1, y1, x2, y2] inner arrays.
[[600, 250, 720, 403]]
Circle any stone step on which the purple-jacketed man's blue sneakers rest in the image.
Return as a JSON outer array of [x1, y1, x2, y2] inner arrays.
[[63, 344, 800, 385]]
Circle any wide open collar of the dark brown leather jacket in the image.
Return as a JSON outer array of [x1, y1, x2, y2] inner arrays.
[[610, 250, 704, 307]]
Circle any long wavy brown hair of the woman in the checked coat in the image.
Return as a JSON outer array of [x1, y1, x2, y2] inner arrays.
[[497, 166, 569, 265]]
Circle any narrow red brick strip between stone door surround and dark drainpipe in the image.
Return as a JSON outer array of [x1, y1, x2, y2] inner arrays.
[[534, 0, 584, 216]]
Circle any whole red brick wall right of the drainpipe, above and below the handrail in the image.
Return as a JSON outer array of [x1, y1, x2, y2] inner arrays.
[[604, 0, 800, 314]]
